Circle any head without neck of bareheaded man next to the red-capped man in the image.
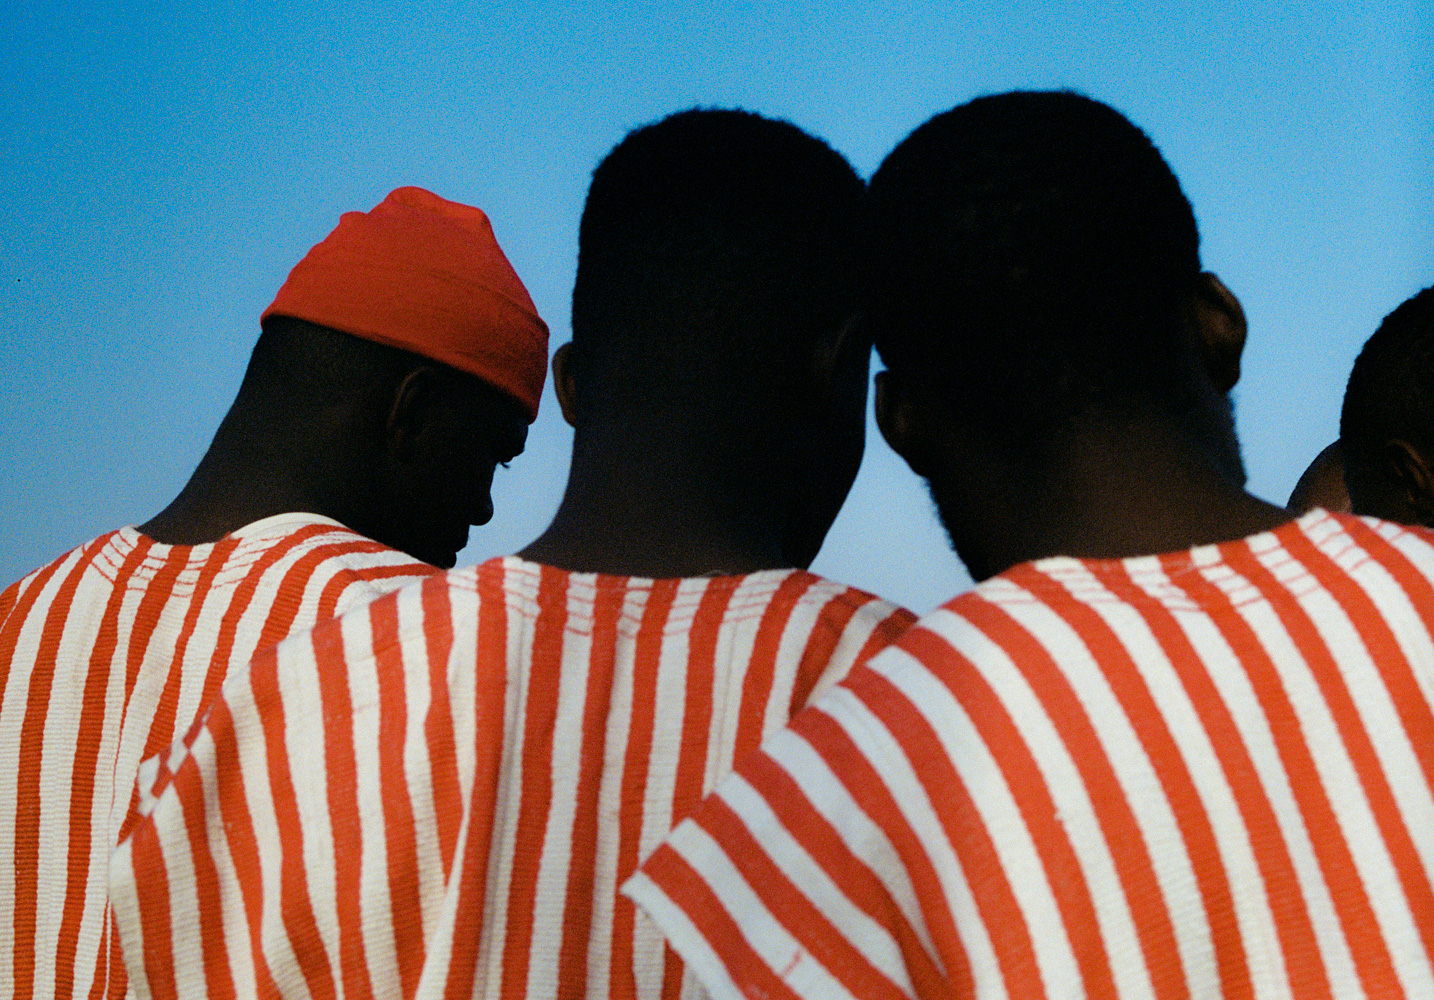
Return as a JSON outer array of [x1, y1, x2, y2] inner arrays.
[[555, 110, 870, 565]]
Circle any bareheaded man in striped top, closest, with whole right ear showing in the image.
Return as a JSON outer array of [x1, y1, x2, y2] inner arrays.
[[625, 93, 1434, 1000]]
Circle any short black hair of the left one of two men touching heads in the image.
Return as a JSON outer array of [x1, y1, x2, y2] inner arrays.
[[572, 109, 865, 419]]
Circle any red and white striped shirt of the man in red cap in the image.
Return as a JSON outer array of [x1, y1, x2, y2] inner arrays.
[[0, 514, 436, 1000]]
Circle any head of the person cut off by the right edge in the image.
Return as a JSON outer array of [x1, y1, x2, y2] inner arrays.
[[1339, 287, 1434, 527]]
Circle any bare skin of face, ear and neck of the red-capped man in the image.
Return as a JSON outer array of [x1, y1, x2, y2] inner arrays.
[[139, 364, 528, 568]]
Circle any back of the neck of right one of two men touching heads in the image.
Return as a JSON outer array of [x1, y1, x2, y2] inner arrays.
[[932, 423, 1291, 580]]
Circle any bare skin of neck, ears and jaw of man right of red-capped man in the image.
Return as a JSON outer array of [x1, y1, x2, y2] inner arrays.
[[519, 323, 870, 578]]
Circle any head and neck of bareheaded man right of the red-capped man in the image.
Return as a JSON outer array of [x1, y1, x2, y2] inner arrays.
[[523, 109, 870, 577]]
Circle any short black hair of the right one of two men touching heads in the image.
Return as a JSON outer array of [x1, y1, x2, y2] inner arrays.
[[869, 90, 1200, 446]]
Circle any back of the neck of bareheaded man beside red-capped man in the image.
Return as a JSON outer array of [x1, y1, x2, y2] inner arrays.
[[519, 426, 793, 578]]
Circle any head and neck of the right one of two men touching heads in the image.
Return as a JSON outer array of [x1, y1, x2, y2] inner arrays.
[[870, 92, 1275, 580]]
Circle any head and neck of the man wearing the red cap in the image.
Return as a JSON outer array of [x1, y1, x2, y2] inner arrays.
[[141, 188, 548, 567]]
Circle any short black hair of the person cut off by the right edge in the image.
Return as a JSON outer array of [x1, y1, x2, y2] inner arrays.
[[1339, 286, 1434, 491]]
